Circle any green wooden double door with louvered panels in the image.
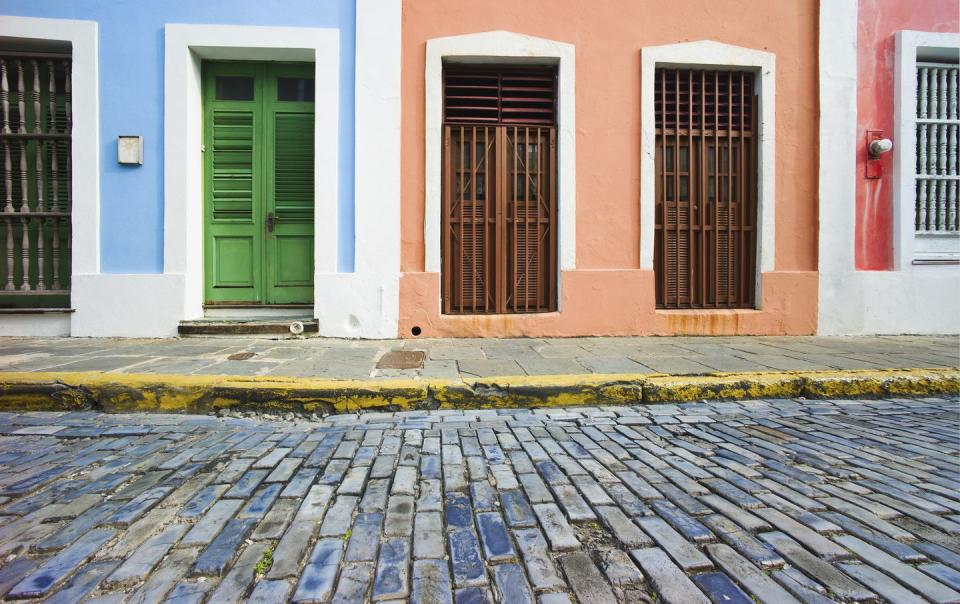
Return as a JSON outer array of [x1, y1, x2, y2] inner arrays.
[[203, 63, 314, 304]]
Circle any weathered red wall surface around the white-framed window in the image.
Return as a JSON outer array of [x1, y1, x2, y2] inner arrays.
[[855, 0, 960, 270]]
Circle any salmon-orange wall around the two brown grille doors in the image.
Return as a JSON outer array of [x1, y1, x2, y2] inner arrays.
[[400, 0, 818, 336]]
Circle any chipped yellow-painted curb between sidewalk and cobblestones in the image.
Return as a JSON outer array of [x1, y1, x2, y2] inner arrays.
[[0, 369, 960, 413]]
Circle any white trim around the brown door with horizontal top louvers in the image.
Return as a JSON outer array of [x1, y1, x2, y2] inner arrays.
[[423, 31, 577, 273]]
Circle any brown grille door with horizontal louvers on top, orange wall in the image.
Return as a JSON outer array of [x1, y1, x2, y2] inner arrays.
[[441, 69, 557, 314]]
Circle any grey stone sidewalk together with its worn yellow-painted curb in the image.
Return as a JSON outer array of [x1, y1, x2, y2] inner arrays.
[[0, 336, 960, 413]]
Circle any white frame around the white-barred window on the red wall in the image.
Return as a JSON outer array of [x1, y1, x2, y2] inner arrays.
[[893, 30, 960, 270]]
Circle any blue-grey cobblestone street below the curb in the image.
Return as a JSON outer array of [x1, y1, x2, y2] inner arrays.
[[0, 399, 960, 604]]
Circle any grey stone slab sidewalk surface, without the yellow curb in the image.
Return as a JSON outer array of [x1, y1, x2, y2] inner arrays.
[[0, 336, 960, 379]]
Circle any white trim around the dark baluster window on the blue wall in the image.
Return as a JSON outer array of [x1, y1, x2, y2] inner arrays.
[[0, 16, 98, 335]]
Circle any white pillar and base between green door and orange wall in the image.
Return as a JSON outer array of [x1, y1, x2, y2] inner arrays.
[[314, 0, 401, 338]]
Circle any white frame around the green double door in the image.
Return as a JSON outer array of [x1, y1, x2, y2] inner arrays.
[[163, 24, 340, 333]]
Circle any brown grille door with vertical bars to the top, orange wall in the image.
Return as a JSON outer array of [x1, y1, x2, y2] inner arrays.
[[654, 69, 758, 308]]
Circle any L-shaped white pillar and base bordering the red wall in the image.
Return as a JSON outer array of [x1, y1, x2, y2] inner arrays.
[[818, 0, 960, 335]]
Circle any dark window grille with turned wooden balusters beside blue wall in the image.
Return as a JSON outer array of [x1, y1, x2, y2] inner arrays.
[[0, 50, 71, 307]]
